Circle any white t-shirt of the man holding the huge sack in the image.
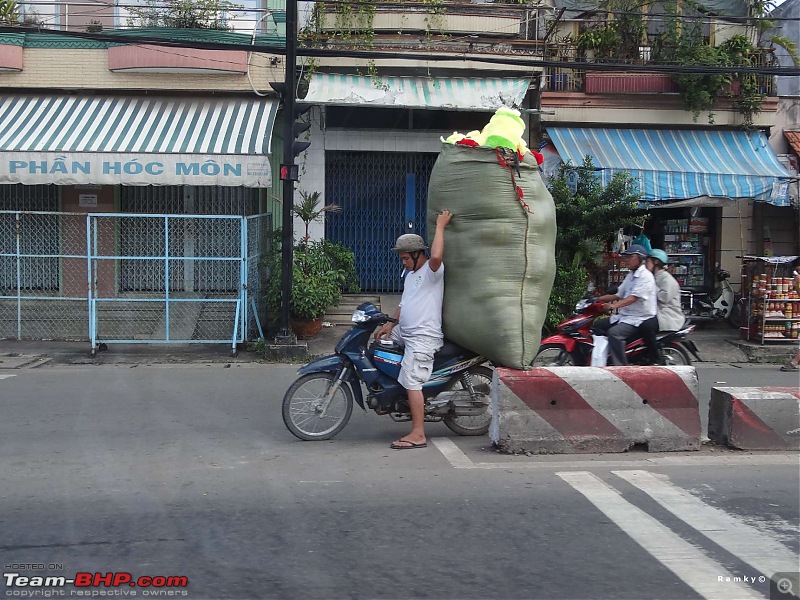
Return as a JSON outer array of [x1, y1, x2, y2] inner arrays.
[[399, 261, 444, 338]]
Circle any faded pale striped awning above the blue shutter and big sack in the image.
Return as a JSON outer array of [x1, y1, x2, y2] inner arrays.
[[302, 73, 531, 111]]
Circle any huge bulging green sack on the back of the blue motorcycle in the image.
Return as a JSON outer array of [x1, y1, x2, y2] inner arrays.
[[427, 144, 556, 369]]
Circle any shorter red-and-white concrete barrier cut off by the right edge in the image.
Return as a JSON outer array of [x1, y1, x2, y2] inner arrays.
[[708, 387, 800, 450]]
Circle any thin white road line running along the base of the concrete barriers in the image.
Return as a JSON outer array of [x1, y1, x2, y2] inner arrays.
[[431, 438, 800, 469]]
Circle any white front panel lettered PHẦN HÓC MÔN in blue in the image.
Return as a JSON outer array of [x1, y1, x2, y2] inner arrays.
[[0, 152, 272, 187]]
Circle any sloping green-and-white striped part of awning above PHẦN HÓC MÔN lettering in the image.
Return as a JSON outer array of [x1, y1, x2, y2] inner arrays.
[[0, 96, 278, 155]]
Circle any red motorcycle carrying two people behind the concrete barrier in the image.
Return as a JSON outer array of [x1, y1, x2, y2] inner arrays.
[[531, 298, 702, 367]]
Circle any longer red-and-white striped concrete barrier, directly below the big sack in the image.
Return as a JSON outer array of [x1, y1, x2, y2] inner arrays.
[[489, 367, 701, 454]]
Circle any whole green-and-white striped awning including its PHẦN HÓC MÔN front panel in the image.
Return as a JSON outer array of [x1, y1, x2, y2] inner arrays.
[[0, 95, 278, 187]]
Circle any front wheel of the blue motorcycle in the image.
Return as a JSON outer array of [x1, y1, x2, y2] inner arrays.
[[282, 373, 353, 441]]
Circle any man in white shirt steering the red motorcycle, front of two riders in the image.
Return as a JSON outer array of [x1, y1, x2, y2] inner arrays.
[[592, 244, 657, 365]]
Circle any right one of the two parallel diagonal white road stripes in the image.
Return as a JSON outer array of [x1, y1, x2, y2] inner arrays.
[[612, 471, 800, 577]]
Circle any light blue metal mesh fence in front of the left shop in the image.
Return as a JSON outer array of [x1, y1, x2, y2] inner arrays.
[[0, 211, 272, 354]]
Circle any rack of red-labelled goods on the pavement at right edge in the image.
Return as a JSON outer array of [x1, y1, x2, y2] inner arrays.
[[741, 256, 800, 345]]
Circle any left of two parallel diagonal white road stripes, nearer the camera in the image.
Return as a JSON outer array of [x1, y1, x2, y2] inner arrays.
[[556, 471, 764, 600]]
